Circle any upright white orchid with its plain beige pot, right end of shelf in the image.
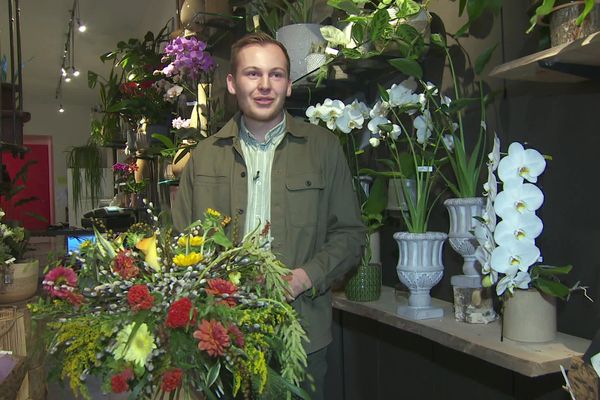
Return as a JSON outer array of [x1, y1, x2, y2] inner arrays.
[[475, 138, 587, 342]]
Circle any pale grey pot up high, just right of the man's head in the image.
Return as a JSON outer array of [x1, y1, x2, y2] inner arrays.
[[275, 24, 325, 81]]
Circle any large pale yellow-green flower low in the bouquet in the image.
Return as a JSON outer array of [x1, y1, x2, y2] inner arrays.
[[113, 323, 156, 367]]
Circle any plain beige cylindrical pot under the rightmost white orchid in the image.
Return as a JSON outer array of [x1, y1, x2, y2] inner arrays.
[[502, 288, 556, 343]]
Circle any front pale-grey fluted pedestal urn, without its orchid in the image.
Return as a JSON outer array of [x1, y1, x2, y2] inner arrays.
[[394, 232, 448, 319]]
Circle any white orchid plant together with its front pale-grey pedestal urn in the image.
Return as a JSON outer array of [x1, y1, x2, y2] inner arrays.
[[368, 78, 451, 319]]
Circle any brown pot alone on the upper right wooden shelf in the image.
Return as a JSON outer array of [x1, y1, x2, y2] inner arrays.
[[550, 1, 600, 46]]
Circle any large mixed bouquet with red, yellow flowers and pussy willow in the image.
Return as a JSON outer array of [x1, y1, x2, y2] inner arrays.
[[30, 203, 307, 399]]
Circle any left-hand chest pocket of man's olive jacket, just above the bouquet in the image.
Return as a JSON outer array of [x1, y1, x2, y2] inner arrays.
[[194, 175, 230, 216]]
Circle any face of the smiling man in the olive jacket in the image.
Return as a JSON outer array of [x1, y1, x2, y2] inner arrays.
[[227, 43, 292, 123]]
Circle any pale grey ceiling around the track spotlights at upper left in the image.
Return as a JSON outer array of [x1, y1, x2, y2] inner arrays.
[[16, 0, 176, 109]]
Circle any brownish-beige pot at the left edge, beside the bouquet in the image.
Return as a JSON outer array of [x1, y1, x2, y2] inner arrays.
[[0, 259, 40, 304]]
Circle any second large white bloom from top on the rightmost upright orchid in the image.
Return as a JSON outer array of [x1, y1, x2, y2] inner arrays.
[[494, 183, 544, 219]]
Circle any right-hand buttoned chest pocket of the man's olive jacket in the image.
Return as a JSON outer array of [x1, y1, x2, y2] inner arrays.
[[285, 173, 325, 227]]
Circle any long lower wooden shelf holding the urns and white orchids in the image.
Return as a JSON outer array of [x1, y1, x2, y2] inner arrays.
[[333, 286, 590, 377]]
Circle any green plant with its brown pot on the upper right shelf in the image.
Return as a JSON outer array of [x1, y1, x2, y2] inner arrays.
[[527, 0, 600, 46]]
